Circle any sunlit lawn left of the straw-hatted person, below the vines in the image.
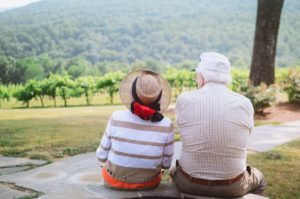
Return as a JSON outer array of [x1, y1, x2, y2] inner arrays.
[[0, 106, 123, 161]]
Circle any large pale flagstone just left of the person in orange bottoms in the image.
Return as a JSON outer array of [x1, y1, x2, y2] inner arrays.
[[0, 153, 102, 198]]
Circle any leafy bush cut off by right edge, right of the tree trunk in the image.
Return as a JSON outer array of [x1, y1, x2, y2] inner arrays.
[[282, 68, 300, 103]]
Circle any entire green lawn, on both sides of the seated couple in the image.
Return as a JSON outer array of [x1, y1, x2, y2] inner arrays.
[[0, 106, 300, 199]]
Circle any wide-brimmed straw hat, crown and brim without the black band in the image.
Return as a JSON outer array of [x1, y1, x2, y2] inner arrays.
[[119, 70, 171, 112]]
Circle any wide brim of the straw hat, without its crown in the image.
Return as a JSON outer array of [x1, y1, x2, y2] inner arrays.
[[119, 70, 171, 112]]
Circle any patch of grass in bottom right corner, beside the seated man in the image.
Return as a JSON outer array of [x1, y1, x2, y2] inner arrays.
[[248, 139, 300, 199]]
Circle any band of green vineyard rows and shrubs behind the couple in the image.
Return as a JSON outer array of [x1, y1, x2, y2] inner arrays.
[[0, 68, 300, 112]]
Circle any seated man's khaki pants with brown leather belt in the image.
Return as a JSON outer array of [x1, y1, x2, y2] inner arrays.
[[170, 166, 266, 197]]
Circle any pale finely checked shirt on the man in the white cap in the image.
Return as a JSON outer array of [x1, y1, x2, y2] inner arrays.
[[176, 82, 254, 180]]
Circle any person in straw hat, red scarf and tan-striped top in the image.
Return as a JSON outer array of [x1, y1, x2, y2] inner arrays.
[[96, 70, 174, 190]]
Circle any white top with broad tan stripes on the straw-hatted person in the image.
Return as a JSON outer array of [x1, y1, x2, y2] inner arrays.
[[96, 110, 174, 182]]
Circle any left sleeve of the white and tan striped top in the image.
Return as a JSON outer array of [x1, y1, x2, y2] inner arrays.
[[96, 117, 112, 163]]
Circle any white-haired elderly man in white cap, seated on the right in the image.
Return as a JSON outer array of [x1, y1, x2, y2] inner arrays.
[[170, 52, 266, 197]]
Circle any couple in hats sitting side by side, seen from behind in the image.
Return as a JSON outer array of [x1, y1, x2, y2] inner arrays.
[[97, 52, 266, 197]]
